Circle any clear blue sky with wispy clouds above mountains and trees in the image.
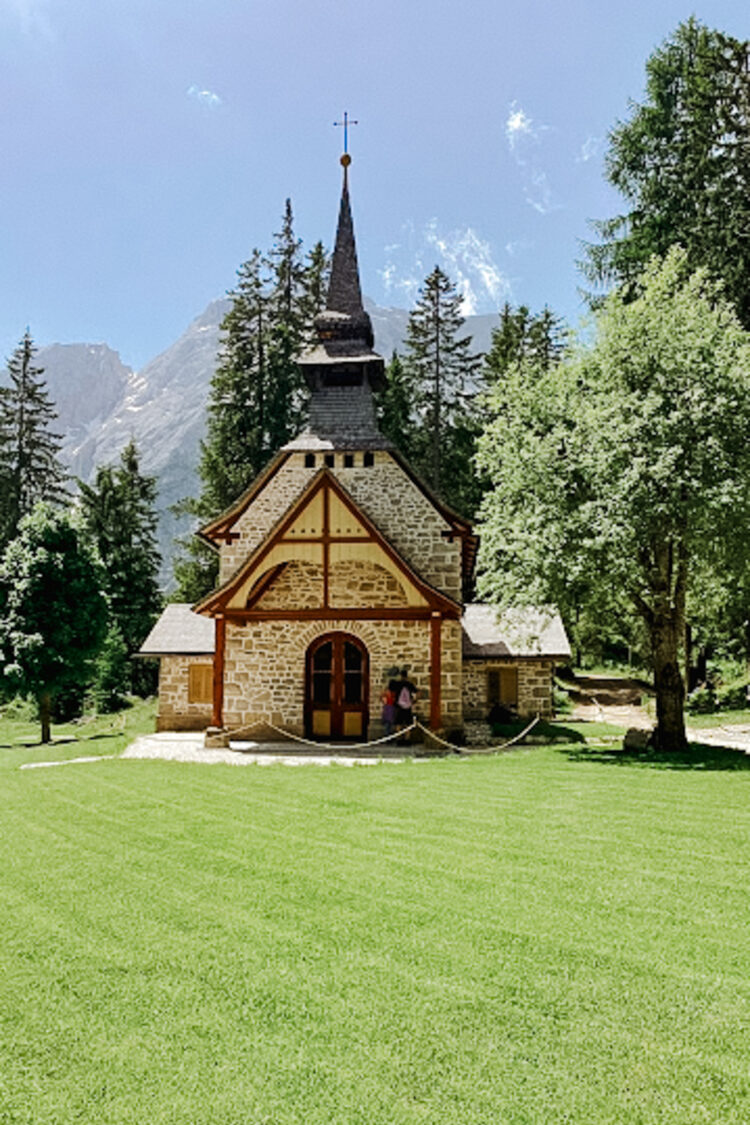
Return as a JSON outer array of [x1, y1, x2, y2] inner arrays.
[[0, 0, 750, 369]]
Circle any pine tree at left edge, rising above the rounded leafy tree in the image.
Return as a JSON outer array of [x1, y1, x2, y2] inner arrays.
[[0, 329, 65, 548]]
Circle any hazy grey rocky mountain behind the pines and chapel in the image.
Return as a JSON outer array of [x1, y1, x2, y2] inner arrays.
[[37, 298, 497, 583]]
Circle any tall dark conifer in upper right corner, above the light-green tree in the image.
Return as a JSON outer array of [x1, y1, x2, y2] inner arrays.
[[586, 18, 750, 327]]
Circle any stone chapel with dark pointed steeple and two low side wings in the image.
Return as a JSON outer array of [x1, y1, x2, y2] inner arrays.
[[139, 154, 570, 745]]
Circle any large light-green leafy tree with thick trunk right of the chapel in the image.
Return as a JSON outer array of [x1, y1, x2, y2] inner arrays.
[[479, 250, 750, 748]]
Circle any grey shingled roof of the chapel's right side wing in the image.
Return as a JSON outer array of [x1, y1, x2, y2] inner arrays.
[[461, 602, 570, 660]]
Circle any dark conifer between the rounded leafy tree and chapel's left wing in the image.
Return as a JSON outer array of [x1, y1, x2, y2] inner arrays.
[[79, 441, 162, 694]]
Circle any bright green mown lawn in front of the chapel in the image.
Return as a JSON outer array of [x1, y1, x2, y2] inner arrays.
[[0, 736, 750, 1125]]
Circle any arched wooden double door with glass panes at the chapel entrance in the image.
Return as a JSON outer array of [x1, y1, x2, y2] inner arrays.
[[305, 632, 370, 740]]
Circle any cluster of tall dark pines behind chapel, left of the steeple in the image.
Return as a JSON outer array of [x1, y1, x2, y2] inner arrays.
[[174, 200, 328, 601]]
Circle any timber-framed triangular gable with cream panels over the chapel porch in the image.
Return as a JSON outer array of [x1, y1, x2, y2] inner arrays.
[[196, 469, 460, 618]]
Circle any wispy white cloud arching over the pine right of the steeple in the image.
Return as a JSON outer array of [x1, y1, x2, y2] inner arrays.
[[379, 219, 510, 316]]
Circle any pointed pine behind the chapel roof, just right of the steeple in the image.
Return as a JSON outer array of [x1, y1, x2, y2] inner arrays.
[[404, 266, 479, 514]]
